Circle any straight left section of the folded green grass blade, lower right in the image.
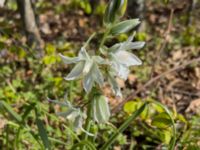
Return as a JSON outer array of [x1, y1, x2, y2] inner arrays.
[[100, 102, 148, 150]]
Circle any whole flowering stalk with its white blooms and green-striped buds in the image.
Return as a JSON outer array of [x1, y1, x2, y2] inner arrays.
[[50, 0, 145, 134]]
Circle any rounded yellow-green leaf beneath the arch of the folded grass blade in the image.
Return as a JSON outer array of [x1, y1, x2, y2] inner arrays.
[[151, 112, 172, 128]]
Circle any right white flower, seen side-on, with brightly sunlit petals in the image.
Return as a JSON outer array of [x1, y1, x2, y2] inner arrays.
[[104, 36, 145, 97]]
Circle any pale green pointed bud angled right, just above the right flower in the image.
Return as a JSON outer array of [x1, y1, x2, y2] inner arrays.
[[110, 19, 140, 35]]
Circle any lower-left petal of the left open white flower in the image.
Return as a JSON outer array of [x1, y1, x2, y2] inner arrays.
[[65, 62, 85, 80]]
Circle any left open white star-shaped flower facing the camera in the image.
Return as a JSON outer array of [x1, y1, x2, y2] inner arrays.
[[60, 47, 106, 93]]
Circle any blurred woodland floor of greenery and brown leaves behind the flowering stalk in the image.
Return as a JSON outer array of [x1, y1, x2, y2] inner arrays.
[[0, 0, 200, 150]]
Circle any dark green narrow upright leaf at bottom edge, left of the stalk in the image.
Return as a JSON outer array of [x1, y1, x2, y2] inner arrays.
[[36, 112, 51, 150]]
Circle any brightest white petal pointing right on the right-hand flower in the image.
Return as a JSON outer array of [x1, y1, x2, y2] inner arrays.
[[115, 51, 142, 66]]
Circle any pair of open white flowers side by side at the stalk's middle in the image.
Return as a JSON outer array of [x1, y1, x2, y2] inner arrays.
[[60, 36, 144, 97]]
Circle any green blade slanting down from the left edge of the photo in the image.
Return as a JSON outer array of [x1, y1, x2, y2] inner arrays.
[[0, 101, 22, 123]]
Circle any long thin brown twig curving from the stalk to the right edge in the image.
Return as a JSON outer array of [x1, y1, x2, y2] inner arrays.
[[112, 57, 200, 113]]
